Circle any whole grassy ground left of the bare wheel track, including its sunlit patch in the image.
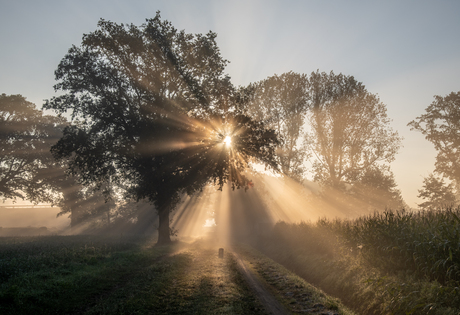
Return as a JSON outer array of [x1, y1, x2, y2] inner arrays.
[[0, 236, 264, 314]]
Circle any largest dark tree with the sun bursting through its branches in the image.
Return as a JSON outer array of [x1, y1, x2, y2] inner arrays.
[[44, 13, 278, 243]]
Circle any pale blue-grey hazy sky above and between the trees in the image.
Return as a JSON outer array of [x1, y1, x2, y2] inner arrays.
[[0, 0, 460, 206]]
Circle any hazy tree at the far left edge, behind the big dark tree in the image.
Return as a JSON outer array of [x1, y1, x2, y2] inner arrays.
[[0, 94, 65, 202]]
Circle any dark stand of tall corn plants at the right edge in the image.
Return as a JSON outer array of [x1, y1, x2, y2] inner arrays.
[[332, 208, 460, 284]]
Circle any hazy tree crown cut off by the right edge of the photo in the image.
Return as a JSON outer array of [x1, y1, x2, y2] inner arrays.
[[408, 91, 460, 184]]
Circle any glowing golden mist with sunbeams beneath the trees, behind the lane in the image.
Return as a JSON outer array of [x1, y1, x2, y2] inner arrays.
[[167, 170, 404, 247]]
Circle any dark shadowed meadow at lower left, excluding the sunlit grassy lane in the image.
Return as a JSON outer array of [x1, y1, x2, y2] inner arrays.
[[0, 236, 172, 314]]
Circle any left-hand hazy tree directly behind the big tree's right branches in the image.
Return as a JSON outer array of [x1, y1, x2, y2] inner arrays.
[[246, 72, 308, 180]]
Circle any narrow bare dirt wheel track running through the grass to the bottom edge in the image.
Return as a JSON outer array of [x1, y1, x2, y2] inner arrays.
[[233, 252, 290, 315]]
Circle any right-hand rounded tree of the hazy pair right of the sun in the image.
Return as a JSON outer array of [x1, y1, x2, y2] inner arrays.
[[305, 71, 401, 190]]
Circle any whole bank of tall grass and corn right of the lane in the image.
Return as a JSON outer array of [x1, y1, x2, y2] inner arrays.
[[259, 208, 460, 314]]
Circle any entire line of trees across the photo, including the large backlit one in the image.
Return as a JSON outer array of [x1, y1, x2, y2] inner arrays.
[[0, 13, 460, 243]]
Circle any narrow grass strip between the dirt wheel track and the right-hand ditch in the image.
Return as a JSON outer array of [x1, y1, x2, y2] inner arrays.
[[235, 244, 354, 315]]
